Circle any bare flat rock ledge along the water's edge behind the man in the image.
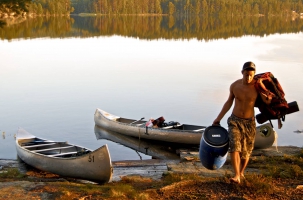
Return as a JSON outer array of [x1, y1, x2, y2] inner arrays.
[[0, 146, 303, 181]]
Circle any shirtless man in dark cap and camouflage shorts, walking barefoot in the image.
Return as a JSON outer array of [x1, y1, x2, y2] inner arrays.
[[213, 62, 258, 183]]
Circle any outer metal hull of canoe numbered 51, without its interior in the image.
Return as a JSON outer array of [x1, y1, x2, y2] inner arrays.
[[16, 129, 113, 183]]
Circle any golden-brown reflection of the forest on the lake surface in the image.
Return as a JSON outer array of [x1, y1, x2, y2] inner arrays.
[[0, 15, 303, 41]]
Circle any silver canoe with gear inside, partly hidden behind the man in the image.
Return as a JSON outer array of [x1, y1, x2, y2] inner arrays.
[[94, 108, 275, 149]]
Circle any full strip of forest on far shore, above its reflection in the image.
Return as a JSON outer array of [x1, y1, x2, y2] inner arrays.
[[0, 0, 303, 18]]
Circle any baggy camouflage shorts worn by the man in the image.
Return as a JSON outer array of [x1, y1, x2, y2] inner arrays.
[[227, 115, 256, 159]]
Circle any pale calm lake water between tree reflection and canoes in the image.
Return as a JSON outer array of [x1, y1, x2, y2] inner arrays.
[[0, 16, 303, 160]]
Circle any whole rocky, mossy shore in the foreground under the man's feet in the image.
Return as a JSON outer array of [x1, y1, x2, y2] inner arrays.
[[0, 146, 303, 200]]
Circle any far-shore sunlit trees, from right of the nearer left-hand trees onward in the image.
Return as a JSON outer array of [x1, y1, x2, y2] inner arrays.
[[71, 0, 303, 16]]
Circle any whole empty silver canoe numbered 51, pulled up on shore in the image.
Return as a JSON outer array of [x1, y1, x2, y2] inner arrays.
[[16, 129, 113, 183]]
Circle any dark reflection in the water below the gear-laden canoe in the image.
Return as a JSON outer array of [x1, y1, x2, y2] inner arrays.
[[95, 126, 198, 160]]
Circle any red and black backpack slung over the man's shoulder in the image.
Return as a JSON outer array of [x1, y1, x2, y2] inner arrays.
[[254, 72, 288, 128]]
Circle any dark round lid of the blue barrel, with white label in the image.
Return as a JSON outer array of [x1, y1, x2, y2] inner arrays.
[[203, 126, 229, 146]]
